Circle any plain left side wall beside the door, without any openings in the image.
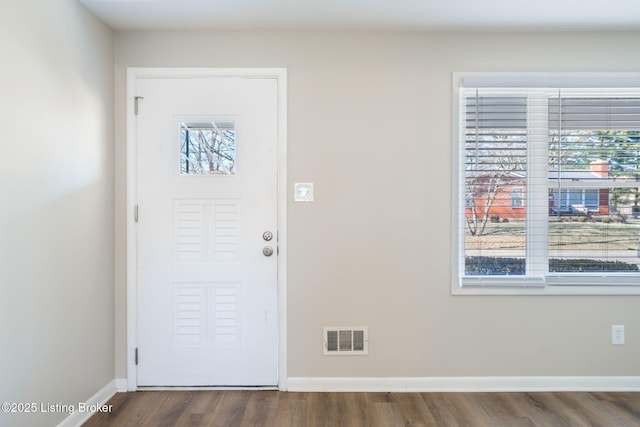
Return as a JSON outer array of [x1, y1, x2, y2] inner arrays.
[[0, 0, 114, 427]]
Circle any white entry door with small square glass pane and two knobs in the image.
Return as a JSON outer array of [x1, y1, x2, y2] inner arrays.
[[136, 77, 278, 386]]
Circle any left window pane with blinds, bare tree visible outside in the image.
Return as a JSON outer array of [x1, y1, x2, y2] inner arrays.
[[464, 91, 528, 275]]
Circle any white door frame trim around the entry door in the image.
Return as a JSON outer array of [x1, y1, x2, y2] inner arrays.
[[126, 67, 287, 391]]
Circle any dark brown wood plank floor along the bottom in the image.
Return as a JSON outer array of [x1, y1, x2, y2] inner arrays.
[[84, 391, 640, 427]]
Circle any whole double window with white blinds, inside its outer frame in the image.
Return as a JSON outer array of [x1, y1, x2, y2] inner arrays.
[[455, 76, 640, 287]]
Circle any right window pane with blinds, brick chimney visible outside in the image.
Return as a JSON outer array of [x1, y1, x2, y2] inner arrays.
[[548, 92, 640, 272]]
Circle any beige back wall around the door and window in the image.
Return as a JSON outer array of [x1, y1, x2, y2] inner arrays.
[[115, 32, 640, 377]]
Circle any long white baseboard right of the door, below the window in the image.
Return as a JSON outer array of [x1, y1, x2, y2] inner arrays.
[[287, 377, 640, 392]]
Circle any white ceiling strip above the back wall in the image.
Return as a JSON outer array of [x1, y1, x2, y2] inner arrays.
[[79, 0, 640, 31]]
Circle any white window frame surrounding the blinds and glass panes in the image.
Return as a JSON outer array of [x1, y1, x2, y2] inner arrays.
[[451, 72, 640, 295]]
